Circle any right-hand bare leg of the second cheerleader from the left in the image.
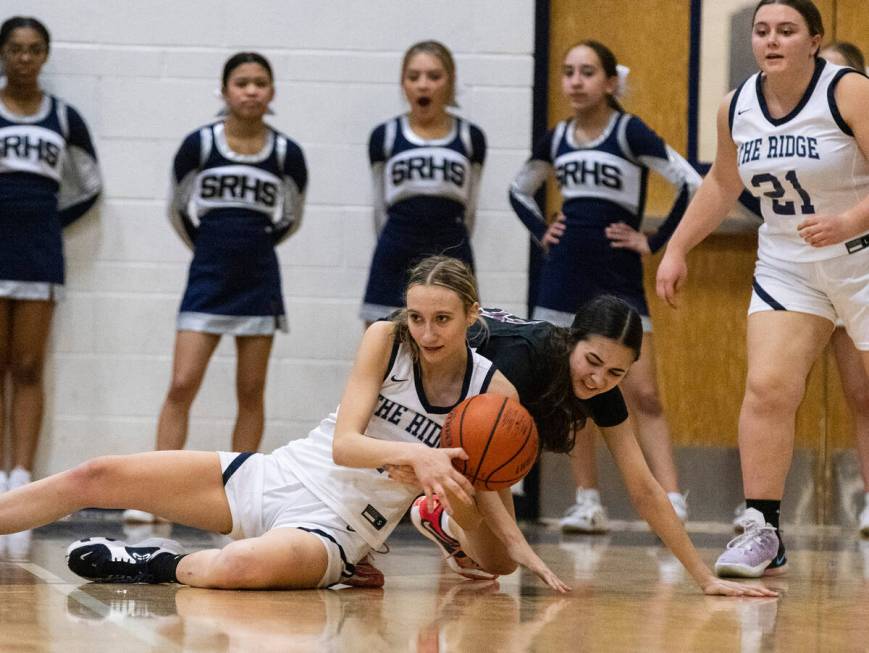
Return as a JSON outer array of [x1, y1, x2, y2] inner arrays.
[[232, 336, 273, 451]]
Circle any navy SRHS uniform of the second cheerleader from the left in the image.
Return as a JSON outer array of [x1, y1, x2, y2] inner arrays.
[[170, 122, 308, 336]]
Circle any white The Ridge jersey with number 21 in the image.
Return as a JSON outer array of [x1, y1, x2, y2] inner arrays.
[[730, 59, 869, 261]]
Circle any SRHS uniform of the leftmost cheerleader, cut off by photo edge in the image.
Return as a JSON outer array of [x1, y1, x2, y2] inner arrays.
[[0, 93, 102, 300]]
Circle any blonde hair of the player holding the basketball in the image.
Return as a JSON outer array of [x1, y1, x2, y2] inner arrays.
[[392, 256, 486, 360]]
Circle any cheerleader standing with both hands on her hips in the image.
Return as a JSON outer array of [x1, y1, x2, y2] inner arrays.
[[510, 40, 700, 533]]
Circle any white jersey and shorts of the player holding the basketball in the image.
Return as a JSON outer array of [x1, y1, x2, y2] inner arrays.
[[220, 343, 496, 586]]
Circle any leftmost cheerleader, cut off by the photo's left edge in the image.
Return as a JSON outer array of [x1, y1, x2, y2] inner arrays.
[[0, 16, 101, 492]]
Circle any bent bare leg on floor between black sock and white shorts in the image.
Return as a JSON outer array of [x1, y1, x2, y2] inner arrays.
[[176, 528, 328, 589]]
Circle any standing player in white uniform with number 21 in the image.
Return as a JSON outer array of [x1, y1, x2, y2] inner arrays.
[[657, 0, 869, 576]]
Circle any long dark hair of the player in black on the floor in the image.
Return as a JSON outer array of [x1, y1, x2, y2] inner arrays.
[[530, 295, 643, 453]]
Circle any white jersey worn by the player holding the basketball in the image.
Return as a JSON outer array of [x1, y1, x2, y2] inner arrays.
[[273, 343, 495, 549]]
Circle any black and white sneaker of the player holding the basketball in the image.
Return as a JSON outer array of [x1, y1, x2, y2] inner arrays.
[[66, 537, 185, 583]]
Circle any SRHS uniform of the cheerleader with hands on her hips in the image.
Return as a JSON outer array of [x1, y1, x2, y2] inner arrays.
[[510, 112, 700, 331]]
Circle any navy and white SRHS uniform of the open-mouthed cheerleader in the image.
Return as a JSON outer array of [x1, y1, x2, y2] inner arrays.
[[360, 116, 486, 322]]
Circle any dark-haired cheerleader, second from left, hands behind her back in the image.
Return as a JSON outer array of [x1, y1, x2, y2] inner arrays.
[[124, 52, 307, 521]]
